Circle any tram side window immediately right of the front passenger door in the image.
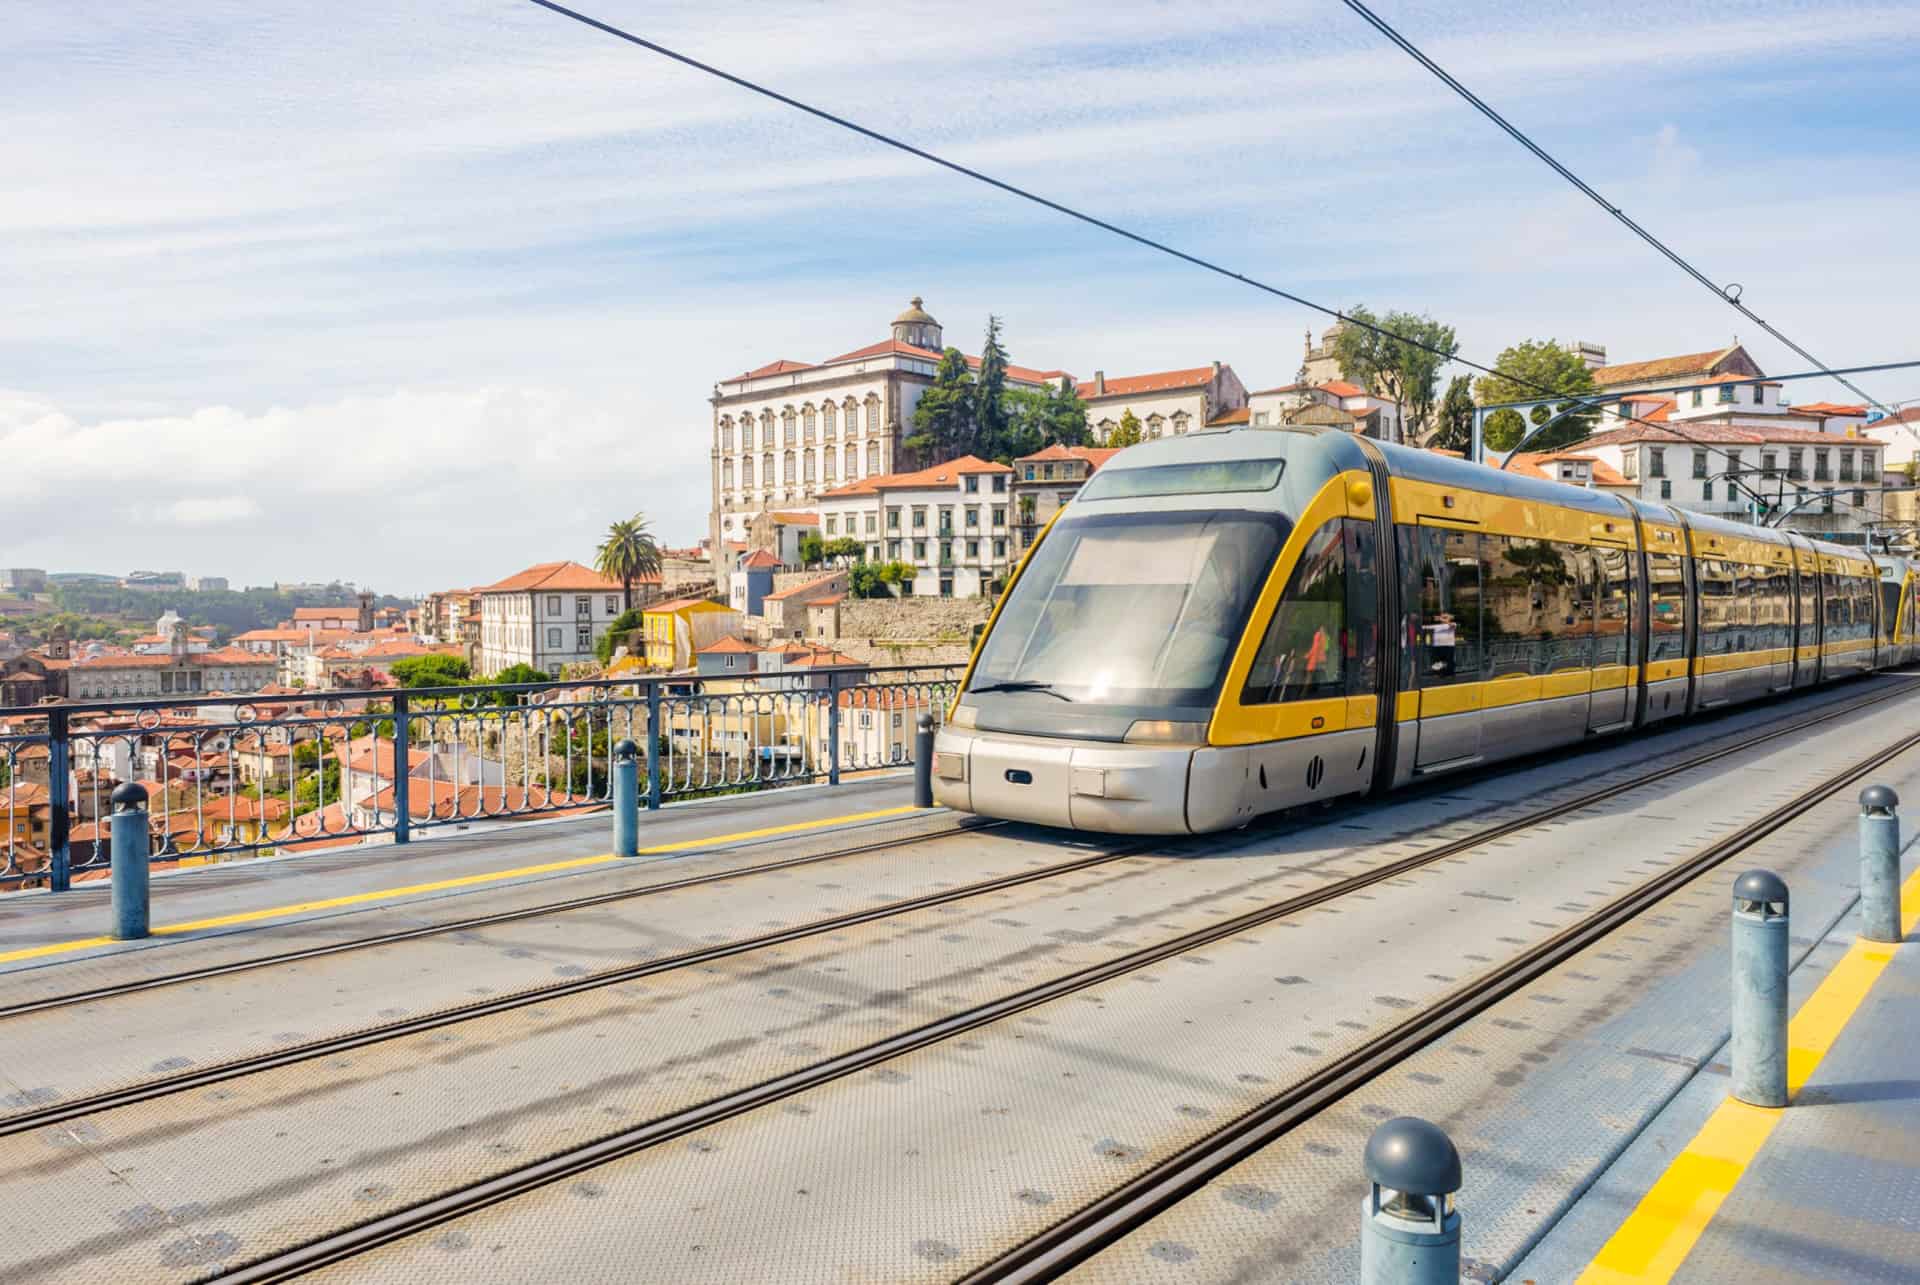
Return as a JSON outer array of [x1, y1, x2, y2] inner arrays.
[[1480, 536, 1592, 678]]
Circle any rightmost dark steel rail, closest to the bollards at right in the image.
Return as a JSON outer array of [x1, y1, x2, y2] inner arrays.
[[960, 732, 1920, 1285]]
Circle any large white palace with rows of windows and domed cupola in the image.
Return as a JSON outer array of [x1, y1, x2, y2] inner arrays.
[[710, 298, 1068, 580]]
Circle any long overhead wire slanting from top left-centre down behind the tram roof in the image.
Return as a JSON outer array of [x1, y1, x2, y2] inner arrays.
[[528, 0, 1889, 491]]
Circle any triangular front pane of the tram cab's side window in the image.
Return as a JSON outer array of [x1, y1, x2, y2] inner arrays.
[[1240, 521, 1350, 705]]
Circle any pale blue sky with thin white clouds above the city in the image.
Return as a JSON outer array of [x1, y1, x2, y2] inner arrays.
[[0, 0, 1920, 594]]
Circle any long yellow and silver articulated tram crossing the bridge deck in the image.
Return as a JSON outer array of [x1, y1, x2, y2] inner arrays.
[[933, 428, 1916, 834]]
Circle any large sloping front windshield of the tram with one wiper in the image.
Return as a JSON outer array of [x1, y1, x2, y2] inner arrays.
[[968, 511, 1288, 716]]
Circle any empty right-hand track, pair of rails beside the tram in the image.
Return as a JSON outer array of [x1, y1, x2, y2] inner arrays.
[[198, 676, 1920, 1281]]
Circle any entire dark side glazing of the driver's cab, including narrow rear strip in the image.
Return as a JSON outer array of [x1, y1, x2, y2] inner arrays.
[[1240, 519, 1380, 705]]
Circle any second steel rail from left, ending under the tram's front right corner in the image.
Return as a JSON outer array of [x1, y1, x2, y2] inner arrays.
[[0, 822, 1165, 1137]]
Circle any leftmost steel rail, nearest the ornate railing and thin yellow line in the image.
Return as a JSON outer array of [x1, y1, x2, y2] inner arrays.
[[0, 818, 1010, 1022]]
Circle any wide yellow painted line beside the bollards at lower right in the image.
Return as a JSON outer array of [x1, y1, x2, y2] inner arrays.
[[1580, 870, 1920, 1285]]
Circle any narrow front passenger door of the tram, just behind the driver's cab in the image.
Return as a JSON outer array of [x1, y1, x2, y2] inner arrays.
[[1409, 526, 1484, 770]]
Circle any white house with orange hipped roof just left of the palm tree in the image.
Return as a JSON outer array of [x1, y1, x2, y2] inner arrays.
[[474, 563, 629, 678]]
